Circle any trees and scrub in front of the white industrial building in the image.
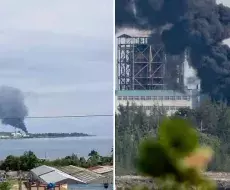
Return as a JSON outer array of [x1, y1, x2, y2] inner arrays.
[[115, 100, 230, 175]]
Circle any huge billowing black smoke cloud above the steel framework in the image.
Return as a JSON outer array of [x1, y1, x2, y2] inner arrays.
[[116, 0, 230, 102]]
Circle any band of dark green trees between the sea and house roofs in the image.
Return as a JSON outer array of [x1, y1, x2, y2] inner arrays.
[[0, 150, 113, 171]]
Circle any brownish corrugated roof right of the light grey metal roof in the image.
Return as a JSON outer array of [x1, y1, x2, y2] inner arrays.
[[55, 165, 104, 183]]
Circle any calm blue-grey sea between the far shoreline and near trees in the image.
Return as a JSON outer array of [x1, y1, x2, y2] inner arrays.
[[0, 137, 113, 160]]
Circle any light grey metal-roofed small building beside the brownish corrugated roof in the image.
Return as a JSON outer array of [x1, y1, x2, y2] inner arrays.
[[29, 165, 84, 185]]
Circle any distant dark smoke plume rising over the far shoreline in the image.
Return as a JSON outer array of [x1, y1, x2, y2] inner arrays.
[[0, 86, 28, 133]]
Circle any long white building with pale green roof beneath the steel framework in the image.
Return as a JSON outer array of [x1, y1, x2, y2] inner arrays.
[[116, 90, 199, 115]]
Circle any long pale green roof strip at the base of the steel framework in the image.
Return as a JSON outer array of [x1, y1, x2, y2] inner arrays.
[[115, 90, 189, 96]]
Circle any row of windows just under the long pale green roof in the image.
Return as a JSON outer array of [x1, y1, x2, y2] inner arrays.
[[118, 96, 190, 100]]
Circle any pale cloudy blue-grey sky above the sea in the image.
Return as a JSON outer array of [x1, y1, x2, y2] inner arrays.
[[0, 0, 113, 135]]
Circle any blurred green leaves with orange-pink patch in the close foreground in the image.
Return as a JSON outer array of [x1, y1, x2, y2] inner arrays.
[[137, 119, 216, 190]]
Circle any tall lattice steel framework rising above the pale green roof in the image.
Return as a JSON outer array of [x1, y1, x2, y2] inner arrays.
[[117, 34, 166, 90]]
